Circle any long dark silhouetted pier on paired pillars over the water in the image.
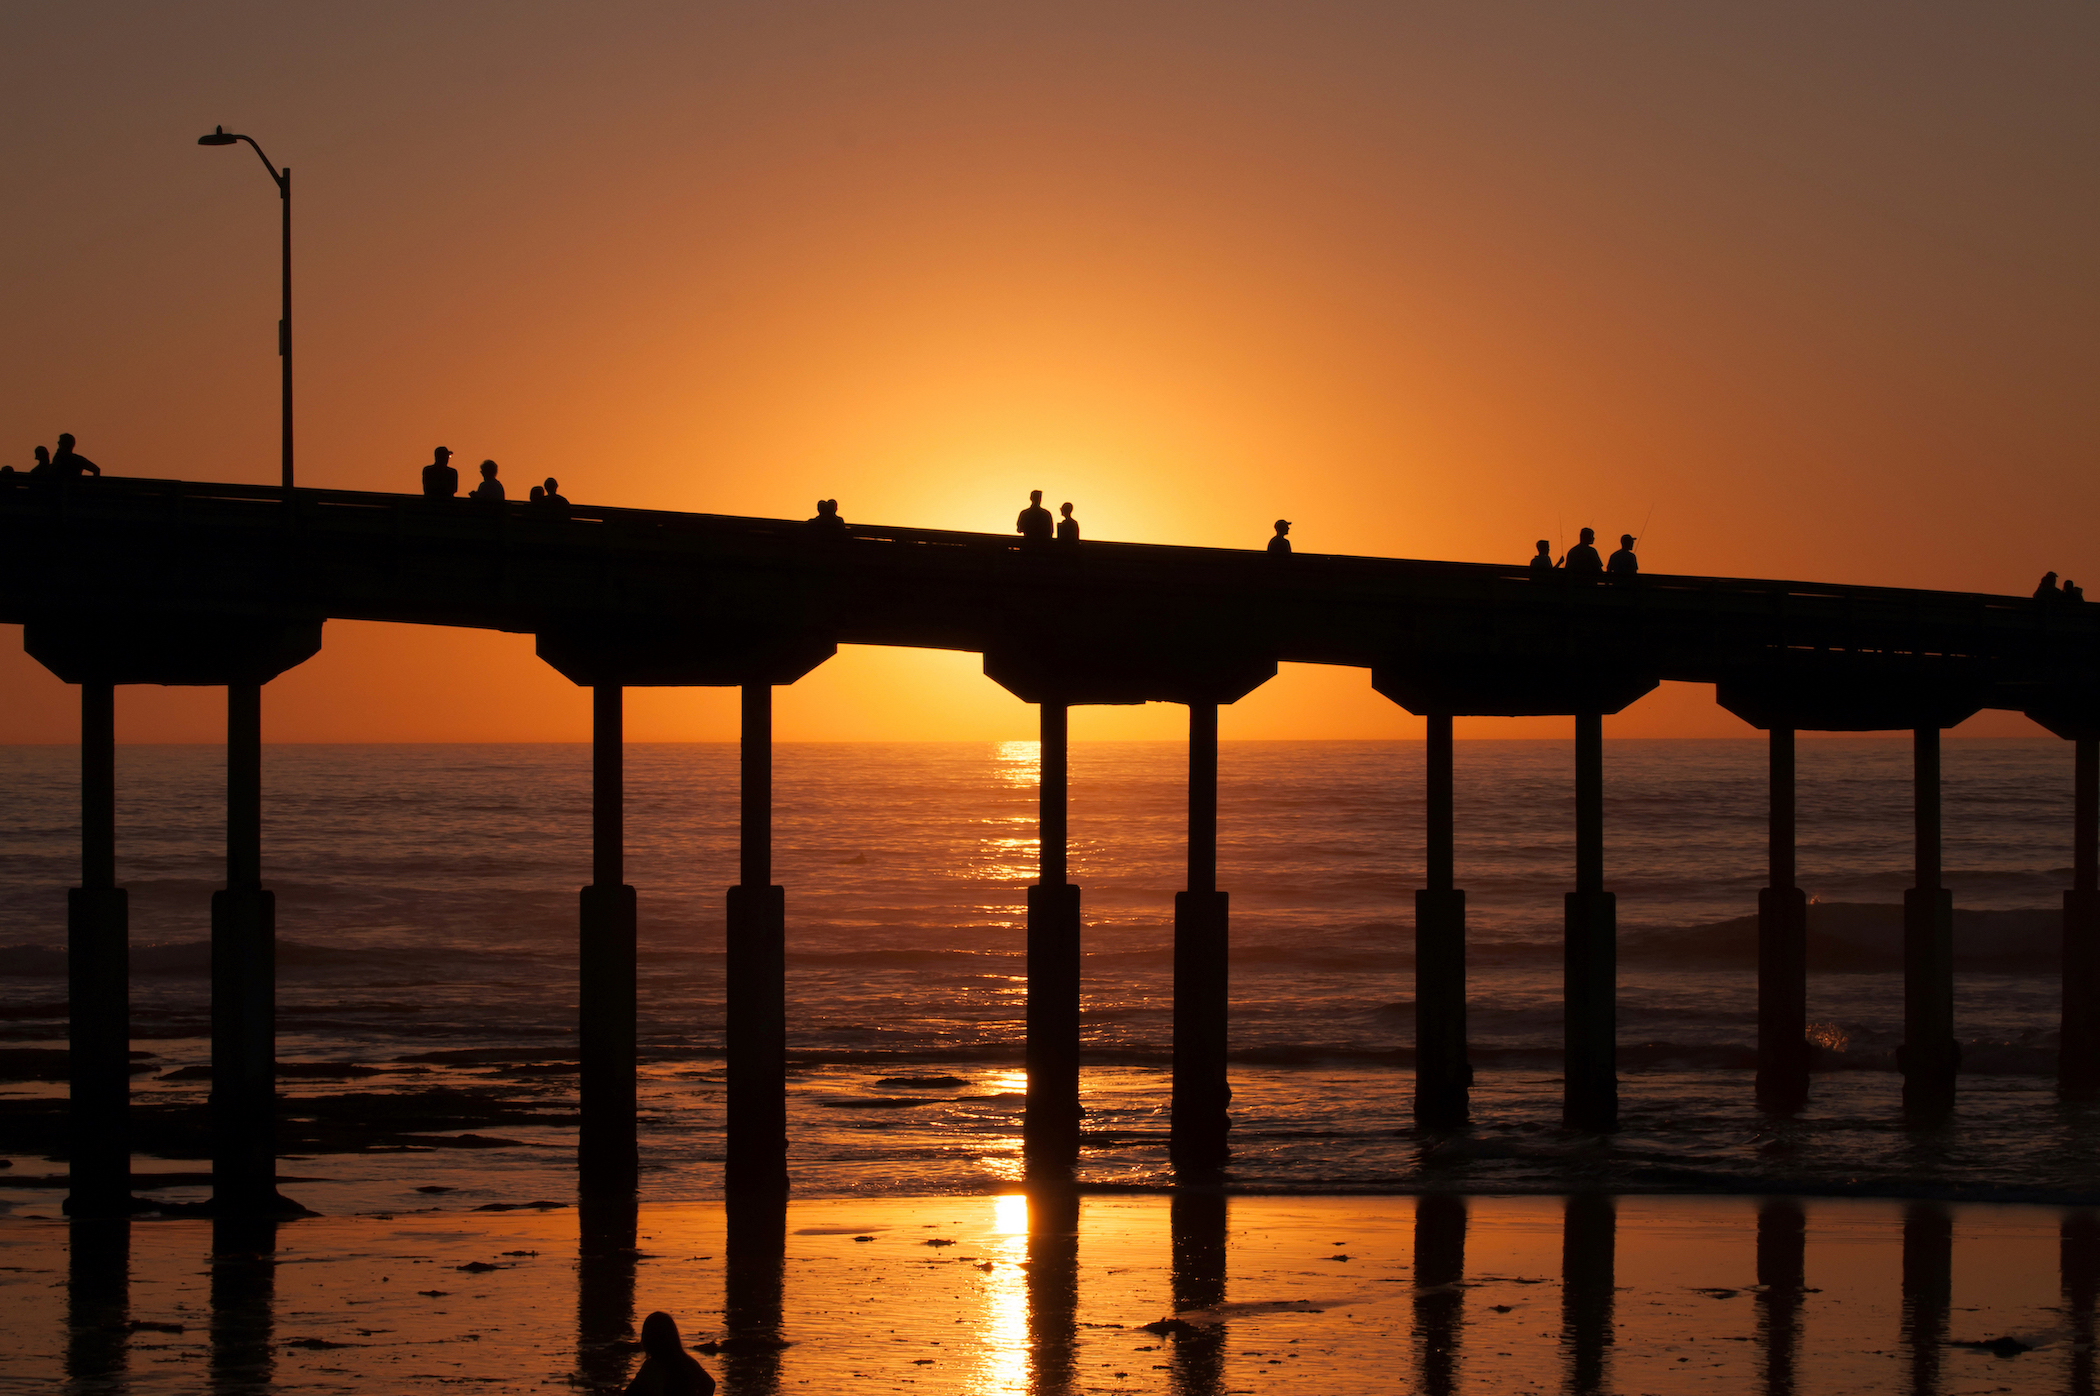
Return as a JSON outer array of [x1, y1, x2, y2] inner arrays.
[[16, 479, 2100, 1217]]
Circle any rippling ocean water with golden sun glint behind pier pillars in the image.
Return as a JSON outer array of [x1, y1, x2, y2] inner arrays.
[[0, 739, 2100, 1211]]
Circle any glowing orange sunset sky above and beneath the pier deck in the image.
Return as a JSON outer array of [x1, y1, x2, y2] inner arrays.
[[0, 0, 2100, 741]]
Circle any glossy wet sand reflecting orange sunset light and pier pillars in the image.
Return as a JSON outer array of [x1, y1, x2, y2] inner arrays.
[[0, 1194, 2074, 1396]]
